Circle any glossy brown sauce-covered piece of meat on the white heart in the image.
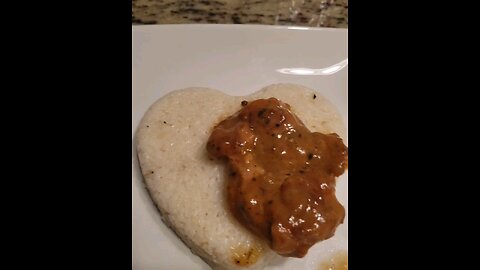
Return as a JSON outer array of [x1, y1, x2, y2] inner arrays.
[[207, 98, 348, 257]]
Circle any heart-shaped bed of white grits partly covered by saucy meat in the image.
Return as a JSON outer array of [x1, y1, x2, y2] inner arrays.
[[136, 84, 346, 269]]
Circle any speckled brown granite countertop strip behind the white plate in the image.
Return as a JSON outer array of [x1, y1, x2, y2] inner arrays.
[[132, 0, 348, 28]]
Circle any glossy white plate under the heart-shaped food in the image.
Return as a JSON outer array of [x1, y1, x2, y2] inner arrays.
[[132, 25, 348, 270]]
